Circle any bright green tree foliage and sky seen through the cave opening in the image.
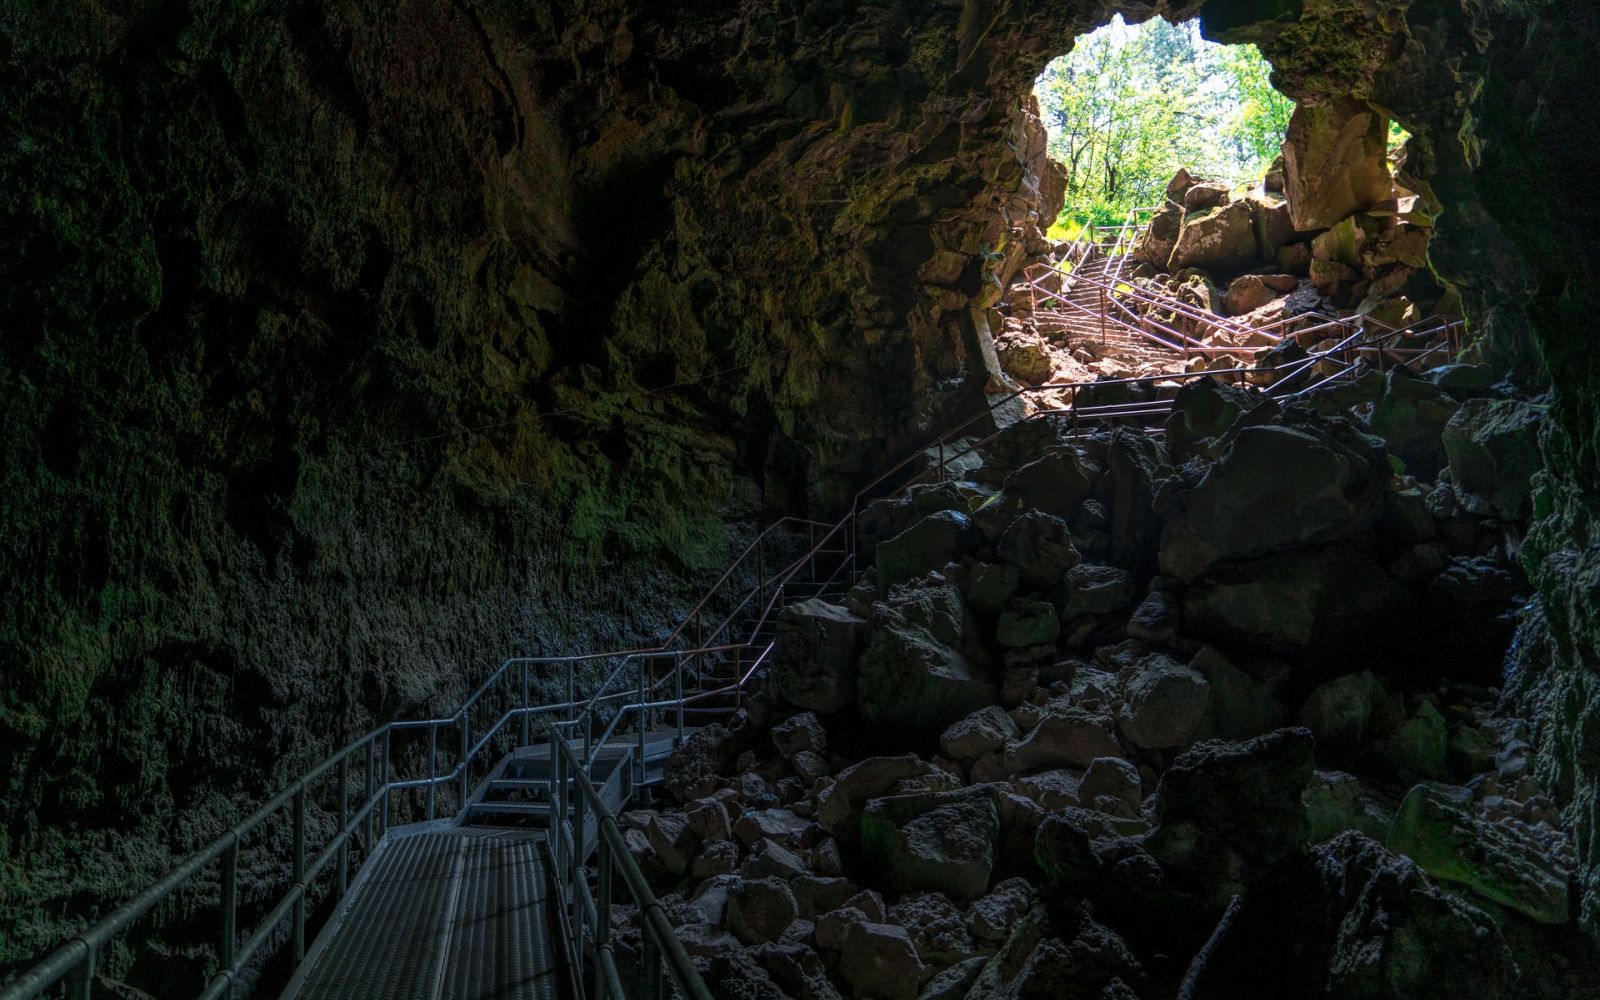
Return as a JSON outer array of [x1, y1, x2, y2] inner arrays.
[[1035, 18, 1294, 226]]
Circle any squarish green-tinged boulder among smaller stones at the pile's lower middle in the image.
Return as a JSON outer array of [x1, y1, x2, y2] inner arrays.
[[861, 789, 1000, 901]]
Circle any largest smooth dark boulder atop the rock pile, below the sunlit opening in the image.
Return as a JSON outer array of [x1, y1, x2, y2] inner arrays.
[[1160, 424, 1382, 581]]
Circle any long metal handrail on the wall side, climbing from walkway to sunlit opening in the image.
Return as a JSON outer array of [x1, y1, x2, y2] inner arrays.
[[0, 304, 1458, 1000]]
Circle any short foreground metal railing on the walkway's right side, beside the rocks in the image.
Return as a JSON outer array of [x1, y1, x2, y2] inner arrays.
[[547, 733, 710, 1000]]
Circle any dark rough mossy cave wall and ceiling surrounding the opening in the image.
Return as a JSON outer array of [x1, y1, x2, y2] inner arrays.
[[0, 0, 1600, 965]]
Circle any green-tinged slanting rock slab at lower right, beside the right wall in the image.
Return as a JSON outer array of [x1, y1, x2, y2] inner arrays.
[[1387, 782, 1573, 923]]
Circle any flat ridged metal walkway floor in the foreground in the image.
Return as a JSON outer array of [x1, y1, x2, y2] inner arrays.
[[283, 827, 563, 1000]]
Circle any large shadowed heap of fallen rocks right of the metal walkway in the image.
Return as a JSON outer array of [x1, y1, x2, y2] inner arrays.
[[613, 365, 1600, 1000]]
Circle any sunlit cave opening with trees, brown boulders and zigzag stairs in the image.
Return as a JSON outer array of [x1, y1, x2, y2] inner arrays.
[[989, 16, 1459, 393]]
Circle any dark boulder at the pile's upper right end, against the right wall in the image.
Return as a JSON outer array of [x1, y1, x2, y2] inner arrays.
[[1443, 400, 1544, 522]]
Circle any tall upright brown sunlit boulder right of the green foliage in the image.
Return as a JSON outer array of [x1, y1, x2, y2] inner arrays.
[[1283, 98, 1394, 232]]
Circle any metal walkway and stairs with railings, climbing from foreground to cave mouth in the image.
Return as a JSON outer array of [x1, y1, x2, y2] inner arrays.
[[0, 296, 1472, 1000]]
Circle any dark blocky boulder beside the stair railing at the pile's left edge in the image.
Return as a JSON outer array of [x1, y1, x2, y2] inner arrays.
[[770, 597, 867, 714]]
